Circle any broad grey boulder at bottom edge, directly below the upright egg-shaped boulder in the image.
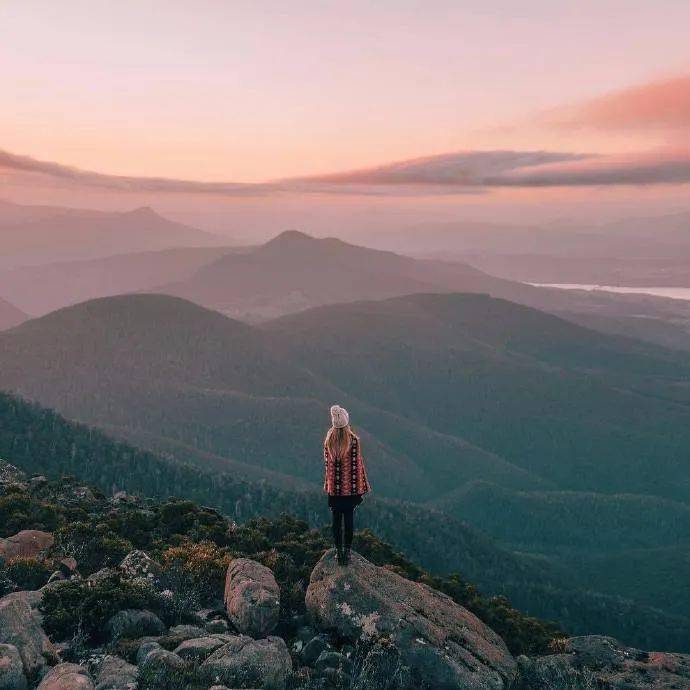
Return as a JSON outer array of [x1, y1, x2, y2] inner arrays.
[[199, 635, 292, 690]]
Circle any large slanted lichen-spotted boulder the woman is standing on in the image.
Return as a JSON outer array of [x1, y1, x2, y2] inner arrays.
[[306, 549, 516, 690]]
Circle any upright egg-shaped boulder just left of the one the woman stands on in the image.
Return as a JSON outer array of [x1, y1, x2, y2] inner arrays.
[[225, 558, 280, 637]]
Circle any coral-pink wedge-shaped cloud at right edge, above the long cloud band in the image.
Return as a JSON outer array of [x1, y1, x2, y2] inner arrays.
[[545, 75, 690, 131]]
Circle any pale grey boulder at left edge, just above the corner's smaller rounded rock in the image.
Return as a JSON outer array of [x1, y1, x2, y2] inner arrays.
[[0, 592, 56, 680]]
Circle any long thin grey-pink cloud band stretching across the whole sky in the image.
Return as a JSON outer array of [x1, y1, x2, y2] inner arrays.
[[0, 148, 690, 197]]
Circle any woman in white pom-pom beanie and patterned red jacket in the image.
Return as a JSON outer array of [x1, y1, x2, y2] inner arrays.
[[323, 405, 371, 565]]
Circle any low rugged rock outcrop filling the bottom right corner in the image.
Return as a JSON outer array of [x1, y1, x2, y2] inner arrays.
[[515, 635, 690, 690]]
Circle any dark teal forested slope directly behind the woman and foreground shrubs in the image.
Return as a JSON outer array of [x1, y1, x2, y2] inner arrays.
[[0, 394, 690, 650]]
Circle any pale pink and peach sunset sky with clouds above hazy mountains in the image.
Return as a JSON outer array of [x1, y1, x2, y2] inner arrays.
[[0, 0, 690, 236]]
